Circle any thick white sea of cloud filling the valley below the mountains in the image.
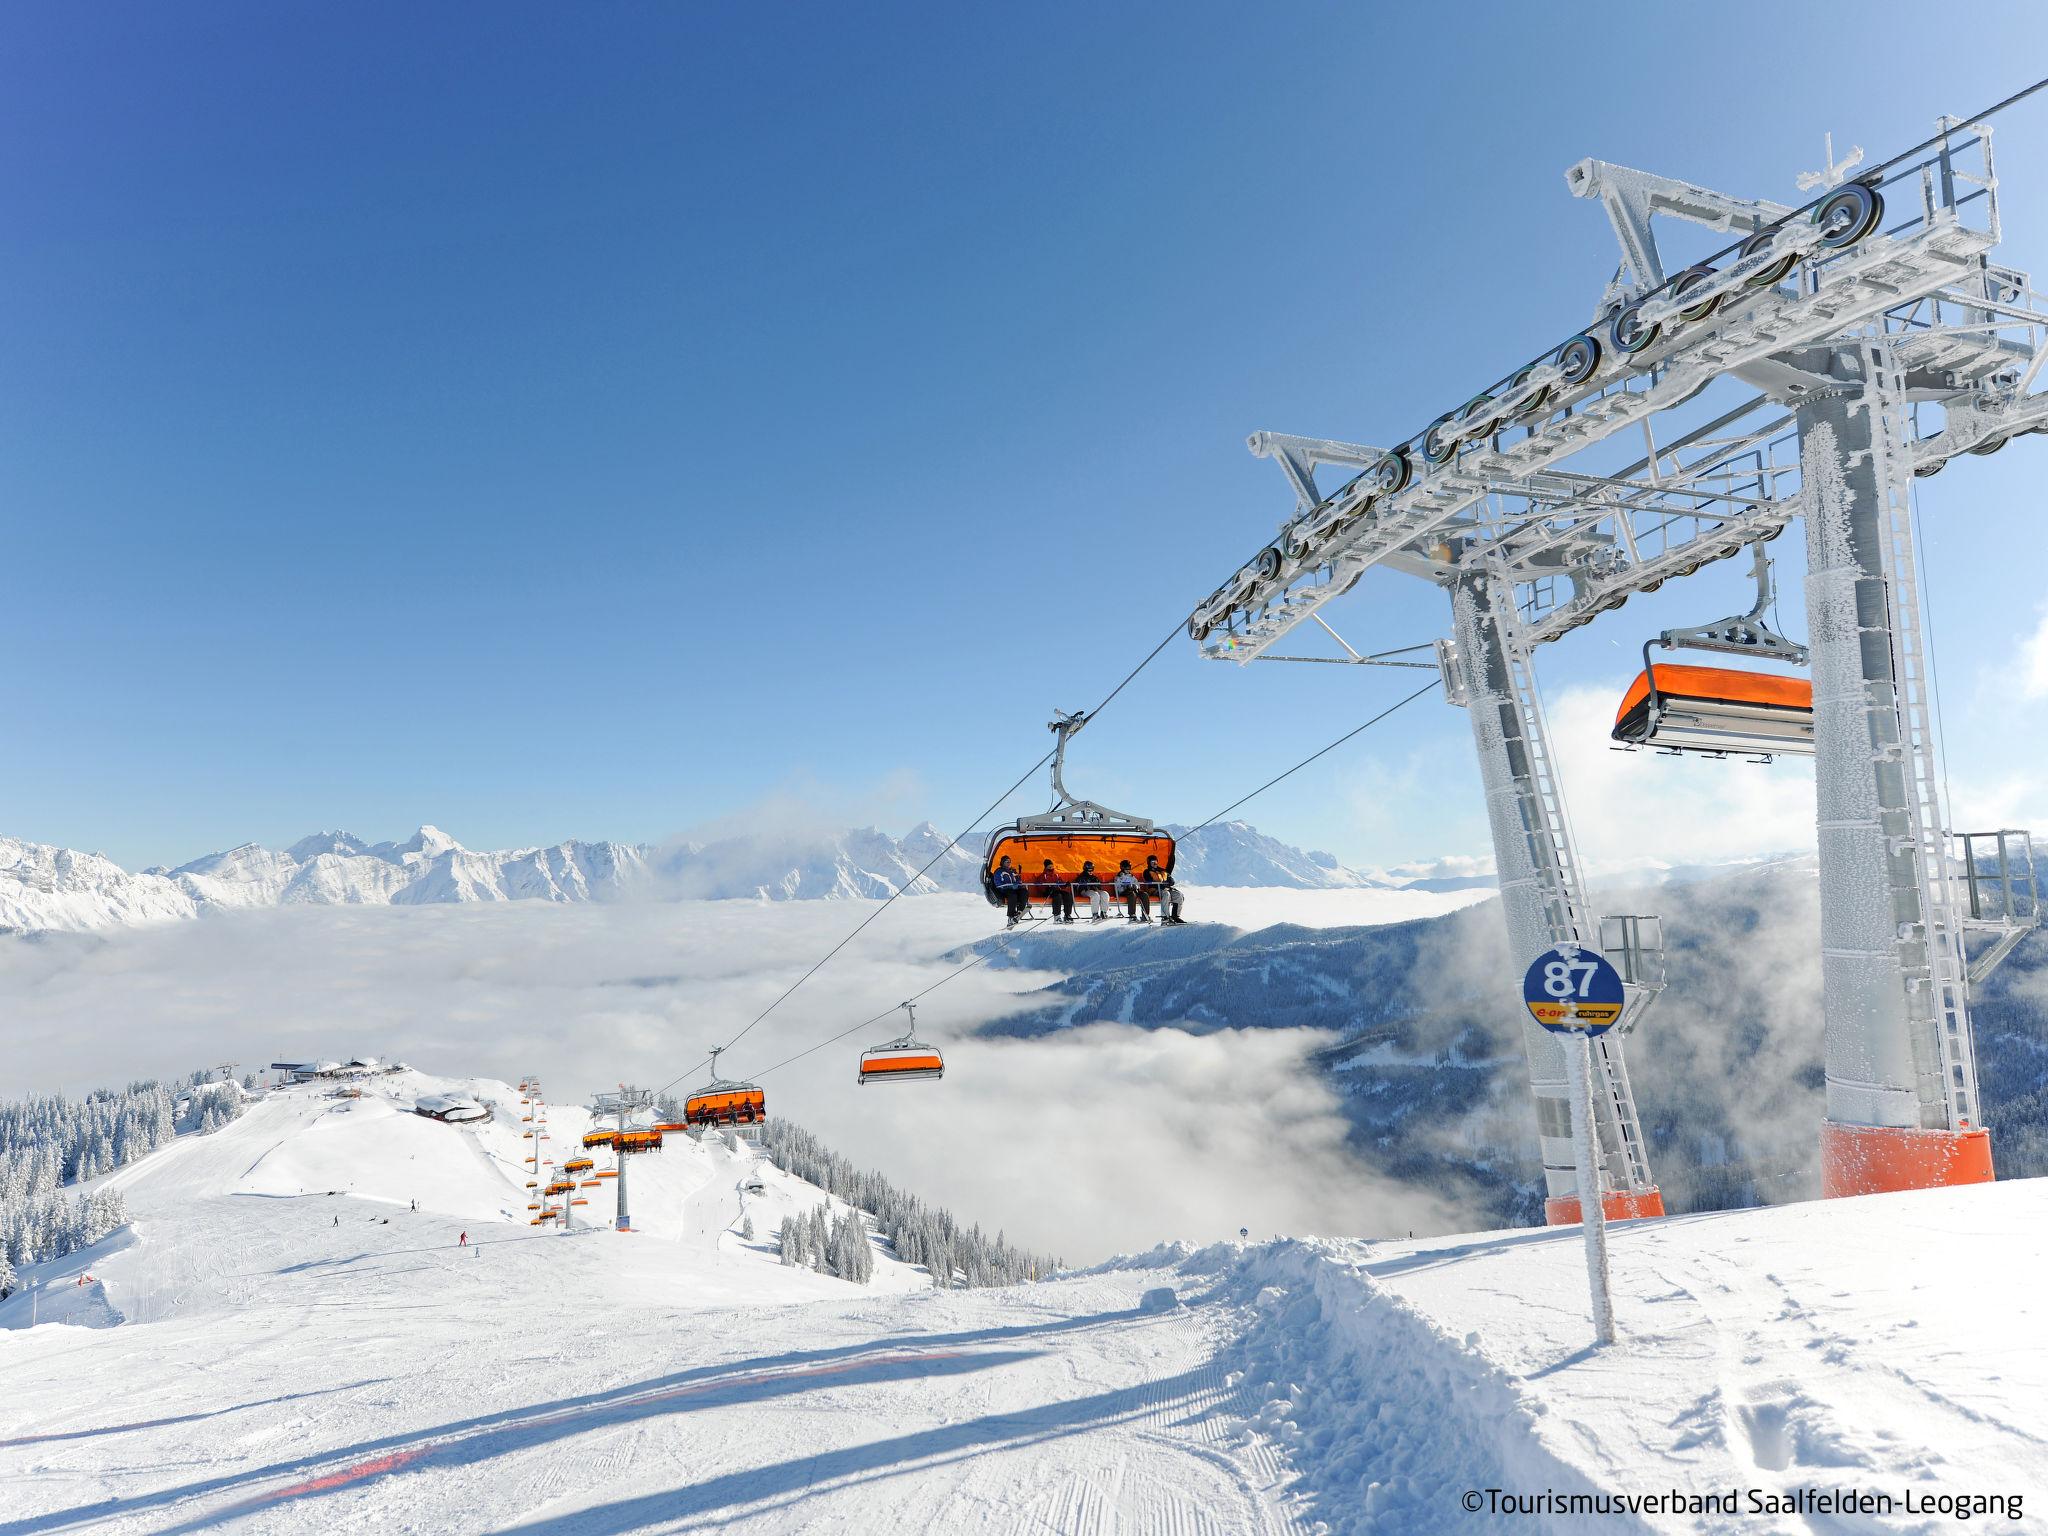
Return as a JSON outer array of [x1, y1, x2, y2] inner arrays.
[[0, 895, 1458, 1262]]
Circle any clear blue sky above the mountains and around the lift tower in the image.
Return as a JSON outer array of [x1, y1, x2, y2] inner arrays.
[[0, 2, 2048, 864]]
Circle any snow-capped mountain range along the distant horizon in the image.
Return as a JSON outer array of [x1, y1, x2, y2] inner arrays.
[[0, 821, 1411, 932]]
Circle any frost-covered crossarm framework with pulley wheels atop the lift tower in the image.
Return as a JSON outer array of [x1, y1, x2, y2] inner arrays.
[[1188, 131, 1998, 662]]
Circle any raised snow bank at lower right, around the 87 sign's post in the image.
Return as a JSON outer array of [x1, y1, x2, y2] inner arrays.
[[1171, 1180, 2048, 1532]]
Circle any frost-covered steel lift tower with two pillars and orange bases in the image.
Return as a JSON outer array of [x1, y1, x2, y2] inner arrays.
[[1190, 119, 2048, 1221]]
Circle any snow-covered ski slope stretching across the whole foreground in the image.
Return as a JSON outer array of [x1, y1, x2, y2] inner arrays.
[[0, 1075, 2048, 1536]]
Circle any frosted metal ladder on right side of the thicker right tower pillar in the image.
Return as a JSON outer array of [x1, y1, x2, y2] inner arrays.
[[1864, 346, 1980, 1130]]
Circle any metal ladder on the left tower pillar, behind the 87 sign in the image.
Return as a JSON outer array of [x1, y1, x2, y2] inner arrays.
[[1501, 618, 1651, 1194]]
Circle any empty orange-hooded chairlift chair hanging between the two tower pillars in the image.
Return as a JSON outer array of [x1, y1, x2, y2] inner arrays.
[[1614, 543, 1812, 762]]
